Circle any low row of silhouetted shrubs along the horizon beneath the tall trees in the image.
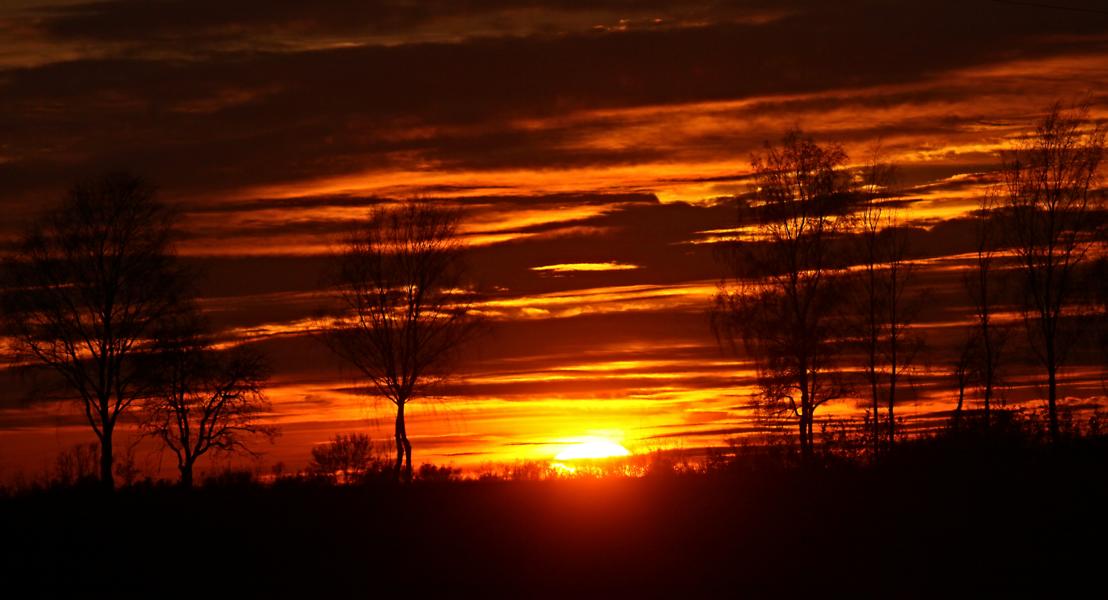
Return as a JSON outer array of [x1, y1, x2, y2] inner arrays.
[[8, 400, 1108, 498]]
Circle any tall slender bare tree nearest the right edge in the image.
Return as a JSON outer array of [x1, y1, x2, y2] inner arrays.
[[1002, 104, 1105, 443]]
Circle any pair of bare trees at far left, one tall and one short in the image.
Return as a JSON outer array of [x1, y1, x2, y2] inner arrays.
[[0, 173, 277, 488]]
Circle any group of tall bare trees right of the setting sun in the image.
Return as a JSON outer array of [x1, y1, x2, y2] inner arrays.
[[711, 104, 1106, 459]]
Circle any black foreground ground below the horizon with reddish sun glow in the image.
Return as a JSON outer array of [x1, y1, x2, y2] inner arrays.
[[0, 444, 1108, 598]]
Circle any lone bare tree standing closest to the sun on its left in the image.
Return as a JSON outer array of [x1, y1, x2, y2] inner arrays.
[[325, 200, 476, 482]]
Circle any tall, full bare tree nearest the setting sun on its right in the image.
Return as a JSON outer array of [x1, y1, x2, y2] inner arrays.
[[712, 131, 851, 461]]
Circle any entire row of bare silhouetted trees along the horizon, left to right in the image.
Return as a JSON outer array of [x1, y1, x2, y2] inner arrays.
[[0, 100, 1108, 488]]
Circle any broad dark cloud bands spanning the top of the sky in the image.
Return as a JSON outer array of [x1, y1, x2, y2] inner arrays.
[[0, 2, 1108, 207]]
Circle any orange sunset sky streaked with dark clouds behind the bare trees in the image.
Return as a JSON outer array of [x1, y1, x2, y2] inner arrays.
[[0, 0, 1108, 477]]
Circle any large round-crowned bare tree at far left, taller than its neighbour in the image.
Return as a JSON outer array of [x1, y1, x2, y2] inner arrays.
[[2, 174, 182, 488]]
